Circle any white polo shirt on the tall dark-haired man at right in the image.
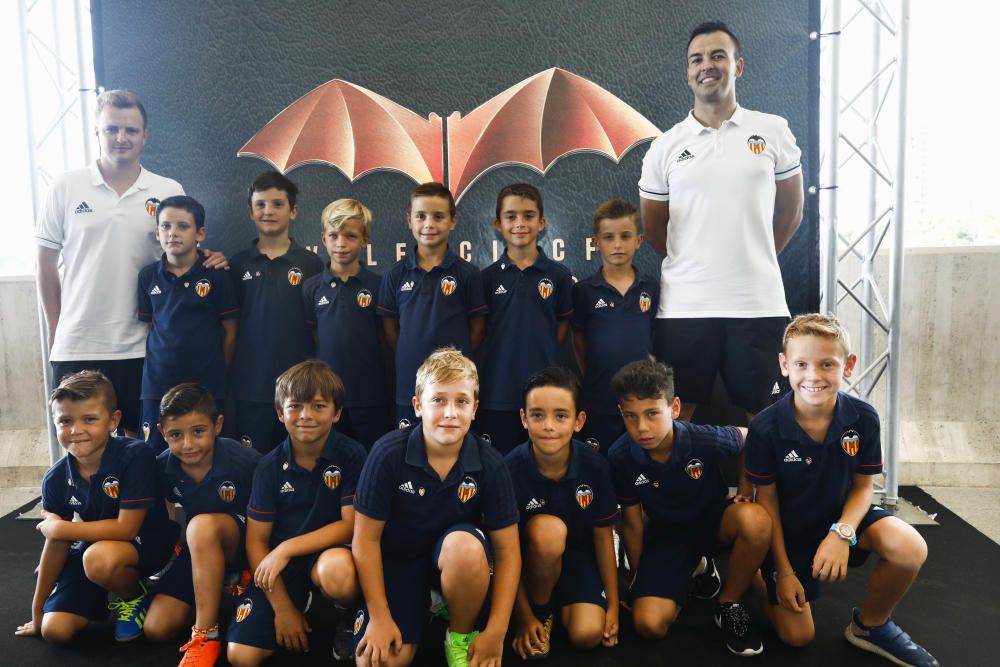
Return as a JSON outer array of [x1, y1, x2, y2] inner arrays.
[[639, 106, 802, 318]]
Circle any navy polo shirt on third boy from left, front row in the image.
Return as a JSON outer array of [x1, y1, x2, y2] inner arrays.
[[247, 431, 365, 549]]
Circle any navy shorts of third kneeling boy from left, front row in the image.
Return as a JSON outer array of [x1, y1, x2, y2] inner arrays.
[[226, 554, 319, 651]]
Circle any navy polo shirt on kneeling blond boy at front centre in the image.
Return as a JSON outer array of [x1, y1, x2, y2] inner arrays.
[[354, 423, 517, 558]]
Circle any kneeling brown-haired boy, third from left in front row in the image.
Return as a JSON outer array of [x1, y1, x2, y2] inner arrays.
[[226, 359, 365, 667]]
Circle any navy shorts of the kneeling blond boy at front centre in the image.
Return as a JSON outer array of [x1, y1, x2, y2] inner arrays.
[[354, 523, 493, 650]]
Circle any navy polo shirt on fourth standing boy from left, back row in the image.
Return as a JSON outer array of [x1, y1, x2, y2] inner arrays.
[[378, 245, 486, 405]]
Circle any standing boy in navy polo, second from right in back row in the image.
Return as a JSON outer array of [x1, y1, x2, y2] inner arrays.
[[476, 183, 573, 454]]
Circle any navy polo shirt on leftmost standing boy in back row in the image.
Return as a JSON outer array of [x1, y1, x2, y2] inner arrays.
[[139, 255, 240, 400]]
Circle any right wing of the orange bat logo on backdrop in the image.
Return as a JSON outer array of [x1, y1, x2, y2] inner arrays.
[[447, 68, 660, 204]]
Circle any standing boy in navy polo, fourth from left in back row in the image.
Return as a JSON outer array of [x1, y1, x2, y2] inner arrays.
[[378, 183, 486, 426]]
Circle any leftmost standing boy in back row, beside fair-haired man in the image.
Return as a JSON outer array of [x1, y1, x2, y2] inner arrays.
[[139, 196, 240, 453]]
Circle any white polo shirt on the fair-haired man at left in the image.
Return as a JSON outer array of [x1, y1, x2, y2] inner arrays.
[[35, 163, 184, 361]]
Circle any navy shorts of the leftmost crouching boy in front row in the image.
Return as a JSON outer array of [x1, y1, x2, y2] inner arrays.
[[42, 521, 180, 620]]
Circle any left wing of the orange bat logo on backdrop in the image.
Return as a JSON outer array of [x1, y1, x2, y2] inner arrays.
[[237, 79, 444, 183]]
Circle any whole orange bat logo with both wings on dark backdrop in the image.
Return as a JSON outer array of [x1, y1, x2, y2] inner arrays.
[[237, 67, 660, 200]]
